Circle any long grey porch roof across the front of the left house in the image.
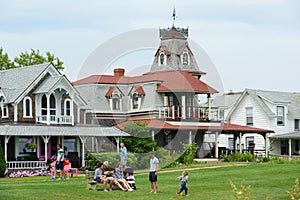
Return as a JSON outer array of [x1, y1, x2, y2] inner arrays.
[[0, 125, 130, 137]]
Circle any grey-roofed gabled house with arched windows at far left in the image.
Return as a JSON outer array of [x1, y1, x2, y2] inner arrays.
[[0, 63, 128, 169]]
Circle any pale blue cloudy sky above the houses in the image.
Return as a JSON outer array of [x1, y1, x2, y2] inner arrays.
[[0, 0, 300, 93]]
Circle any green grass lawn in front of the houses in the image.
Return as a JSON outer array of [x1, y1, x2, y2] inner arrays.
[[0, 163, 300, 200]]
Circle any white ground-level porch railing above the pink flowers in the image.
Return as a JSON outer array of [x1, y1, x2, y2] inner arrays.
[[6, 161, 47, 169]]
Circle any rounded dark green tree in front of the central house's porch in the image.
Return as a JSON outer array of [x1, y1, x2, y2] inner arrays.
[[121, 123, 157, 153]]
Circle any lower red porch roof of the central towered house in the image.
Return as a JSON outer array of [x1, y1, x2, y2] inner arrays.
[[115, 119, 274, 133]]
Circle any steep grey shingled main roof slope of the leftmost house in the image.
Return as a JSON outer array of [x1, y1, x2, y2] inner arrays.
[[0, 63, 56, 103]]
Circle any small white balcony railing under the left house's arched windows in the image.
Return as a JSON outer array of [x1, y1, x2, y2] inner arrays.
[[36, 115, 74, 125]]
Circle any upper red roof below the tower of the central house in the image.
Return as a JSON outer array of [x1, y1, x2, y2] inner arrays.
[[73, 70, 218, 93]]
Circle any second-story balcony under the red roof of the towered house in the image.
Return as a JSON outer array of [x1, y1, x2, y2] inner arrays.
[[159, 106, 222, 121]]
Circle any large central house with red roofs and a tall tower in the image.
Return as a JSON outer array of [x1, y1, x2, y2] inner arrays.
[[73, 26, 272, 157]]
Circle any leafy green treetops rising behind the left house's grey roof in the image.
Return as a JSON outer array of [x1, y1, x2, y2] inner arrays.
[[0, 48, 64, 70]]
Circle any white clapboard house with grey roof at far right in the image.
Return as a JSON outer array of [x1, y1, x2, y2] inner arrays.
[[212, 89, 300, 156]]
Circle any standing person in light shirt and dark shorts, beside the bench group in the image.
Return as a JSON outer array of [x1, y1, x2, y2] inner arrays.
[[149, 152, 159, 194]]
